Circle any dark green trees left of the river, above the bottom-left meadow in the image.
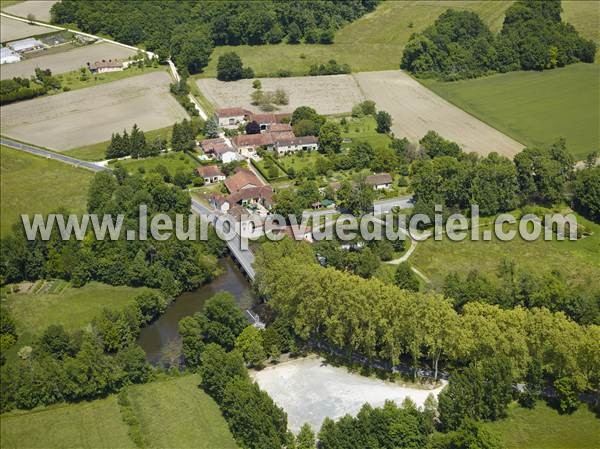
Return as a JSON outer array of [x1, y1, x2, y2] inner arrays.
[[0, 293, 171, 412]]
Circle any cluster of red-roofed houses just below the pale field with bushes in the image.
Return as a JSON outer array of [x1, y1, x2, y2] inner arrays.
[[200, 108, 319, 159]]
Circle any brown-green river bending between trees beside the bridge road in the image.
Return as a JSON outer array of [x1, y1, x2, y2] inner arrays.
[[138, 257, 256, 365]]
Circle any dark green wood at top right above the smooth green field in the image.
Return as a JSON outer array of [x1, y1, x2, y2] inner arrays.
[[401, 0, 596, 81]]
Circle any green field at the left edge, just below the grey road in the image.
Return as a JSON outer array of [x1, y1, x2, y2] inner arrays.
[[0, 146, 93, 236]]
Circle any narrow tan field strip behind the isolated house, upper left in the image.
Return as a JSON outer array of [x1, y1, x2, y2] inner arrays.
[[0, 42, 135, 79]]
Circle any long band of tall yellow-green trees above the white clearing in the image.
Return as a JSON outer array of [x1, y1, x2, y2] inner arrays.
[[256, 240, 600, 402]]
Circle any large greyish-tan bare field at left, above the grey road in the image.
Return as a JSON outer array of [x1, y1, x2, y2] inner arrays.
[[0, 72, 187, 151]]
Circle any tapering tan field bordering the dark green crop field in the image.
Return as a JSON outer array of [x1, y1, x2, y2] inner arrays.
[[354, 70, 523, 157]]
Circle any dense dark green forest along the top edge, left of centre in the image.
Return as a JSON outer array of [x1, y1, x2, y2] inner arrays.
[[52, 0, 378, 73]]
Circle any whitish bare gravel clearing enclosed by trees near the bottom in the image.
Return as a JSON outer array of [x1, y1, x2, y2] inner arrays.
[[252, 357, 443, 432]]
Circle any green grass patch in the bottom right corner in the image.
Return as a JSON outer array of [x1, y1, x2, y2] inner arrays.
[[485, 402, 600, 449]]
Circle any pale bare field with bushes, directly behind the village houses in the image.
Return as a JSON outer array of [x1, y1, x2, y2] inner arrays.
[[196, 75, 363, 114]]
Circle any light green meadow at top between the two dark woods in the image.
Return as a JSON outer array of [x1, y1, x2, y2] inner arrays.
[[200, 0, 511, 77]]
